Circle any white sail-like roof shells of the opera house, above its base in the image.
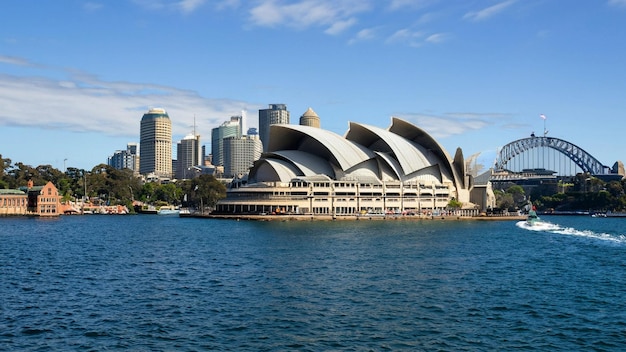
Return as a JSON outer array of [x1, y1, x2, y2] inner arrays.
[[250, 118, 463, 188]]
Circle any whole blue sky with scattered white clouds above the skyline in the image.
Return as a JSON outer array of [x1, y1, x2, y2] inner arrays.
[[0, 0, 626, 170]]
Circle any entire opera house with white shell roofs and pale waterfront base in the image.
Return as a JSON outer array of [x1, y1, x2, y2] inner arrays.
[[214, 118, 493, 217]]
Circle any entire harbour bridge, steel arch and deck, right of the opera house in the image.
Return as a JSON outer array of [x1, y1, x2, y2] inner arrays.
[[482, 134, 621, 181]]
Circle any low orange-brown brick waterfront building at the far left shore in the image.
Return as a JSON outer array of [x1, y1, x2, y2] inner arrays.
[[0, 181, 61, 216]]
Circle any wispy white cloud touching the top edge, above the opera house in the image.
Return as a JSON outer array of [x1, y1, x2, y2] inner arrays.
[[245, 0, 370, 34]]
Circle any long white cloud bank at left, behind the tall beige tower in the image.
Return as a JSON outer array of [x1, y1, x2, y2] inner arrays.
[[0, 67, 261, 142]]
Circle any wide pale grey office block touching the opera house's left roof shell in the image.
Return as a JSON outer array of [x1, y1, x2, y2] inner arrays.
[[223, 134, 263, 177]]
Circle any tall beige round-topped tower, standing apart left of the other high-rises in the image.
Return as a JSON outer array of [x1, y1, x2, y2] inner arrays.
[[139, 109, 172, 178]]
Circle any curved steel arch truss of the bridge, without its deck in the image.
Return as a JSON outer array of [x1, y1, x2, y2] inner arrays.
[[495, 136, 609, 175]]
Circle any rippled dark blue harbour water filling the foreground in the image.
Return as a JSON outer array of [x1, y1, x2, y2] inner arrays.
[[0, 215, 626, 351]]
